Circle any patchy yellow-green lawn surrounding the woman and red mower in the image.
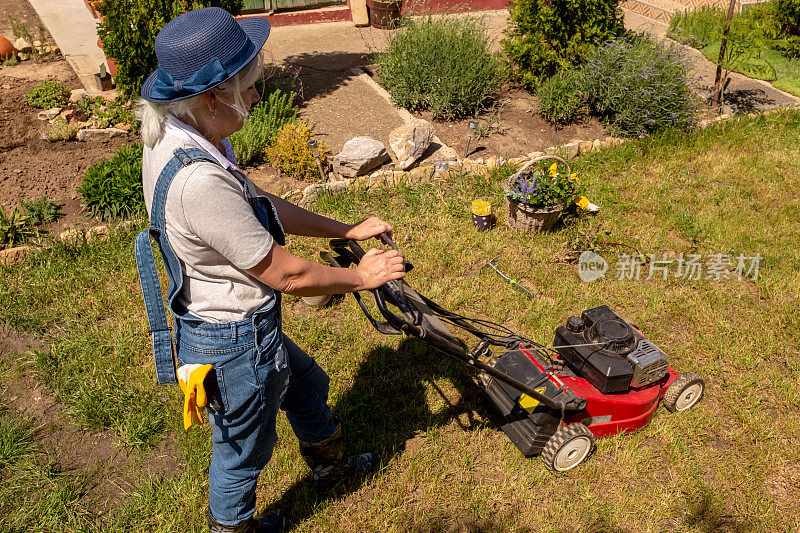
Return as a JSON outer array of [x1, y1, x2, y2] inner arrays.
[[0, 111, 800, 531]]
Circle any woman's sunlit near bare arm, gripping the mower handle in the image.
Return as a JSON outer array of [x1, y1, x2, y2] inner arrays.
[[246, 243, 405, 296]]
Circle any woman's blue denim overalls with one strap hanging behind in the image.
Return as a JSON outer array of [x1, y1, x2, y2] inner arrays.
[[136, 148, 337, 525]]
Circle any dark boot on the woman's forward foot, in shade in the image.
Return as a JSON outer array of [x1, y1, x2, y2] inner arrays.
[[300, 420, 378, 481]]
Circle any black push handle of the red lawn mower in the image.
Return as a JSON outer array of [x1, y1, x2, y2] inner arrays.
[[322, 233, 586, 416]]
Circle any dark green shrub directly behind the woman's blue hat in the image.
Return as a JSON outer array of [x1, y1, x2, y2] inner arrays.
[[97, 0, 242, 98]]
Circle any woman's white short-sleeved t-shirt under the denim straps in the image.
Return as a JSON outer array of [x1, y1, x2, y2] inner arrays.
[[142, 116, 275, 322]]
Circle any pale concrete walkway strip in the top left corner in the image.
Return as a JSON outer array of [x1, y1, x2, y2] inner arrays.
[[29, 0, 106, 95]]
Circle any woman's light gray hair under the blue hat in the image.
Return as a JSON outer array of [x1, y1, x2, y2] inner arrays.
[[136, 49, 269, 148]]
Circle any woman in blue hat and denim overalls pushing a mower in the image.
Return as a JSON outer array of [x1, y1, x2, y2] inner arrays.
[[136, 8, 405, 532]]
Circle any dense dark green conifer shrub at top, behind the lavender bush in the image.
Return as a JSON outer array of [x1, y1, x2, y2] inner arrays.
[[501, 0, 624, 89]]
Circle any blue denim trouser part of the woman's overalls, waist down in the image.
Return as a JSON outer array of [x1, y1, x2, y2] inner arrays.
[[175, 296, 336, 525]]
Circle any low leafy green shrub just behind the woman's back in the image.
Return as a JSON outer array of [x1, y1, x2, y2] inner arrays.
[[78, 144, 145, 220]]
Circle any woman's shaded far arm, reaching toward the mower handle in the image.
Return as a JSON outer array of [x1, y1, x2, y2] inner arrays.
[[256, 187, 392, 241]]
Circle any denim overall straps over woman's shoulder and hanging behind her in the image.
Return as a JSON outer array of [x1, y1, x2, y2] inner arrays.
[[136, 148, 218, 384]]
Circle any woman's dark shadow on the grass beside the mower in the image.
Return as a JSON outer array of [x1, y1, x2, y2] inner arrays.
[[276, 338, 493, 524]]
